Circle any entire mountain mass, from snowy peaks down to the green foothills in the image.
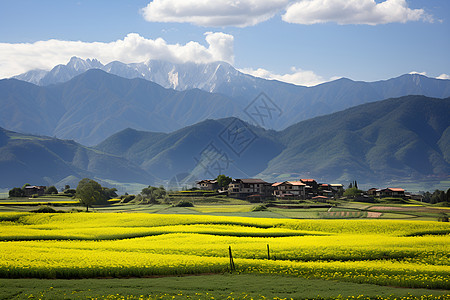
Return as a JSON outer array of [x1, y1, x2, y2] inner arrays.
[[0, 58, 450, 188]]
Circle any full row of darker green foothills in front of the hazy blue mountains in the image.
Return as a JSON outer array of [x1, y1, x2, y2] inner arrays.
[[0, 96, 450, 191]]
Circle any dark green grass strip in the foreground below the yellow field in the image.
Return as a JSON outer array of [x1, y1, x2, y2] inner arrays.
[[0, 274, 450, 300]]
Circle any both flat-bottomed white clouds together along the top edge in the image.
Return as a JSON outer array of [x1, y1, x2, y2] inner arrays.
[[141, 0, 433, 27]]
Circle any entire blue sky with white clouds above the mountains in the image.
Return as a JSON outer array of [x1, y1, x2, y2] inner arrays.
[[0, 0, 450, 86]]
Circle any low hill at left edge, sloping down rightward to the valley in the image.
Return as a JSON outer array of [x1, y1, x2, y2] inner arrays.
[[0, 128, 155, 188]]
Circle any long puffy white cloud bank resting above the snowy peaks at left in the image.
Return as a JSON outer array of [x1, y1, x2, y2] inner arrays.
[[0, 32, 234, 78]]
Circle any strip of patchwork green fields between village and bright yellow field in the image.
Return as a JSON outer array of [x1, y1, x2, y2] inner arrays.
[[0, 193, 450, 221]]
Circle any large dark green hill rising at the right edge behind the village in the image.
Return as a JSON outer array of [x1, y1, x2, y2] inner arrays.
[[261, 96, 450, 183]]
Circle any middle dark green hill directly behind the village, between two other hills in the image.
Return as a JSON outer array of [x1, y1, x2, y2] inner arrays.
[[96, 118, 283, 180]]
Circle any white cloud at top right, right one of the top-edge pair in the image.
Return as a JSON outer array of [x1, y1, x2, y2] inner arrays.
[[282, 0, 433, 25]]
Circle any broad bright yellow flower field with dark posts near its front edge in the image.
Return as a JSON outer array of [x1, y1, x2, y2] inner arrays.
[[0, 213, 450, 289]]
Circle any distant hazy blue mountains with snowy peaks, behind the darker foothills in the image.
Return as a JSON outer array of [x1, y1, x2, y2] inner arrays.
[[0, 58, 450, 145]]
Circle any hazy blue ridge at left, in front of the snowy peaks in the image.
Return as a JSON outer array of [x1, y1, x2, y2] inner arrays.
[[0, 69, 238, 145]]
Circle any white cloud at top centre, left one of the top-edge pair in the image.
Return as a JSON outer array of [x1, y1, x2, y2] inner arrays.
[[141, 0, 289, 27]]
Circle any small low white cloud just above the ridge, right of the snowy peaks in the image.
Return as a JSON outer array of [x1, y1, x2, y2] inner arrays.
[[239, 67, 327, 86]]
